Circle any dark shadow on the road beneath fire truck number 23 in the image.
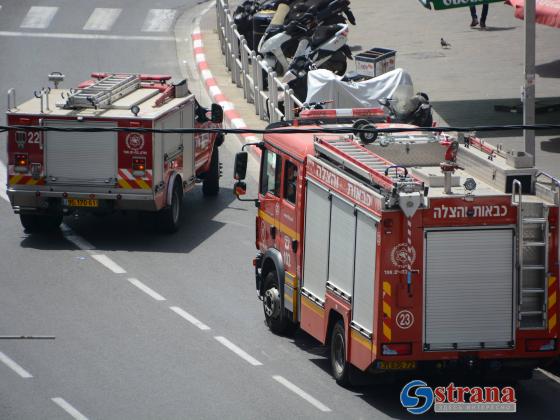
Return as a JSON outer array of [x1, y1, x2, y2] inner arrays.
[[292, 331, 560, 420]]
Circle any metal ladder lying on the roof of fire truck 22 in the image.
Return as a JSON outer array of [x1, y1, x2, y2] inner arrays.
[[59, 74, 140, 108]]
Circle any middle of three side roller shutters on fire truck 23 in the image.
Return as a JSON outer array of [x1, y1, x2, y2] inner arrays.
[[327, 195, 356, 299]]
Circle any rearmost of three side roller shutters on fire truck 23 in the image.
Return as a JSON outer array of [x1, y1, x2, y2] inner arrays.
[[352, 210, 377, 333]]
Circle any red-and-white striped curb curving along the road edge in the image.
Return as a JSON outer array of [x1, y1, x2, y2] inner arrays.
[[191, 26, 258, 149]]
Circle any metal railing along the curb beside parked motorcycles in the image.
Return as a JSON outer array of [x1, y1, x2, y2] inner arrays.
[[216, 0, 303, 122]]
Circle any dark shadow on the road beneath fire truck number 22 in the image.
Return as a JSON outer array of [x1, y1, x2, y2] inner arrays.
[[21, 187, 247, 253]]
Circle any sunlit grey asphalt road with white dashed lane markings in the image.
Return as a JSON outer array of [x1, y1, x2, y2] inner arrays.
[[0, 0, 560, 419]]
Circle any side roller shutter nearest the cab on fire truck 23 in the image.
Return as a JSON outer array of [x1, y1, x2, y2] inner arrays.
[[303, 179, 331, 302]]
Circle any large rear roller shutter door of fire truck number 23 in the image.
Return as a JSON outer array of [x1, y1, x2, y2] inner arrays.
[[424, 228, 514, 350]]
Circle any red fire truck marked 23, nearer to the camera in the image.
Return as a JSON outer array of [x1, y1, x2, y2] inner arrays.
[[235, 110, 560, 384]]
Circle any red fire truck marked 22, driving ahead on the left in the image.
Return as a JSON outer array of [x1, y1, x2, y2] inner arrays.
[[7, 73, 223, 232]]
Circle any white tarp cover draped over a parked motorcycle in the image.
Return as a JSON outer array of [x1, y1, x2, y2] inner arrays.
[[305, 68, 414, 108]]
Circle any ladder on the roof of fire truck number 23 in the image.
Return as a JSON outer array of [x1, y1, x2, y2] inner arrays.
[[315, 137, 421, 190]]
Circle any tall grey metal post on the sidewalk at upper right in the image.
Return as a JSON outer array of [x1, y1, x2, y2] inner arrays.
[[522, 0, 536, 164]]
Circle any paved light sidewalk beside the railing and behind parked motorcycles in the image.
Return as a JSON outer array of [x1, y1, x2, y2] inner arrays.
[[195, 0, 560, 176]]
